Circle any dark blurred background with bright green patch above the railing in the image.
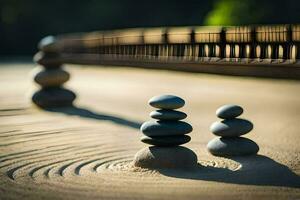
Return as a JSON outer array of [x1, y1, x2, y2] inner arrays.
[[0, 0, 300, 55]]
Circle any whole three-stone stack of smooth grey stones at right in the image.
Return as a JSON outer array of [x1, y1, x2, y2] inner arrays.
[[207, 105, 259, 157]]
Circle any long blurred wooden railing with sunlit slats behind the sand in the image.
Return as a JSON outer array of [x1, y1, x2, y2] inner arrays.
[[40, 25, 300, 63]]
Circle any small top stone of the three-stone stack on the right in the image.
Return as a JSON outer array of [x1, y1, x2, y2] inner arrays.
[[216, 104, 244, 119]]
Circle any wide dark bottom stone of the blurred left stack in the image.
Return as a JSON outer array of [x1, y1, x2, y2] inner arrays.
[[32, 87, 76, 108]]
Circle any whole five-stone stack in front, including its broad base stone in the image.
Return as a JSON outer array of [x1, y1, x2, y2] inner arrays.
[[134, 95, 197, 169]]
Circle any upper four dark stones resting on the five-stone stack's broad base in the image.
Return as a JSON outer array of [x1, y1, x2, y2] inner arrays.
[[141, 95, 193, 146]]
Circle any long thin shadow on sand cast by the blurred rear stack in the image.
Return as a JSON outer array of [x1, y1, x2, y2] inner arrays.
[[44, 106, 141, 129]]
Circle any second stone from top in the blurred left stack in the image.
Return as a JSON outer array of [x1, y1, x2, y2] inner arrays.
[[33, 51, 63, 68]]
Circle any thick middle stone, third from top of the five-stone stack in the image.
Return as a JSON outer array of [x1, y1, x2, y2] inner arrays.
[[140, 121, 193, 137]]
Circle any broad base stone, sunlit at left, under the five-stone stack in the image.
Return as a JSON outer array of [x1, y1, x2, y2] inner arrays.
[[133, 146, 197, 169]]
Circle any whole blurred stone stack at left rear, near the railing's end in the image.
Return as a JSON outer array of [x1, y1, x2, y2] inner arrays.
[[32, 36, 76, 108]]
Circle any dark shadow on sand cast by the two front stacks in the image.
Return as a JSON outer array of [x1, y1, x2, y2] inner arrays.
[[158, 155, 300, 188]]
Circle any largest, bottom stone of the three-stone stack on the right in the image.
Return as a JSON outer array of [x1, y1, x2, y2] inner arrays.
[[207, 137, 259, 156]]
